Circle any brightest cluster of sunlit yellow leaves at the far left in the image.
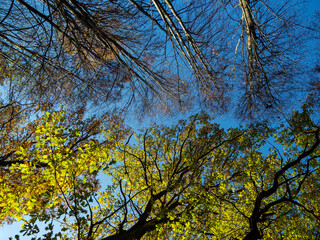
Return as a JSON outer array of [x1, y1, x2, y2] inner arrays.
[[0, 112, 108, 224]]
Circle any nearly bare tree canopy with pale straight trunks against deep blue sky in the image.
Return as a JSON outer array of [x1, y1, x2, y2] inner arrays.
[[0, 0, 319, 119]]
